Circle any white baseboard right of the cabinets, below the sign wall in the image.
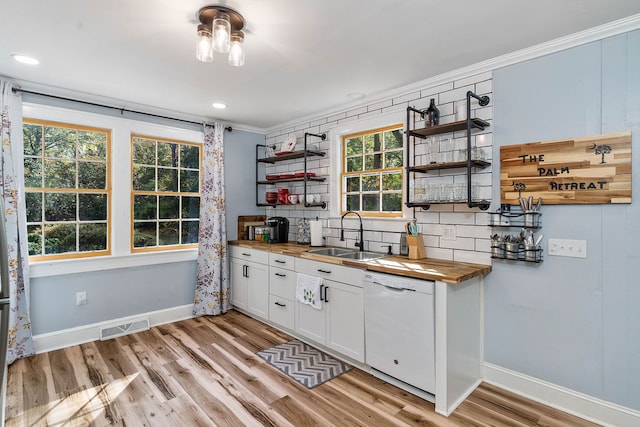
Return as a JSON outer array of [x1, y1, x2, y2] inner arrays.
[[482, 362, 640, 427]]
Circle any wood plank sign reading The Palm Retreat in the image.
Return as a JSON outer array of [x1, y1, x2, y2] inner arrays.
[[500, 131, 631, 205]]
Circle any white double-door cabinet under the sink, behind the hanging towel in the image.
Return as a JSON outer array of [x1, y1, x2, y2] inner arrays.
[[295, 260, 364, 362]]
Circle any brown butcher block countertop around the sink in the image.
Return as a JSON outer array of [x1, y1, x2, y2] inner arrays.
[[229, 240, 491, 283]]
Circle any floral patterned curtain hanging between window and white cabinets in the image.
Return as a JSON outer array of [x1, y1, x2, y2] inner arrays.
[[193, 123, 229, 316]]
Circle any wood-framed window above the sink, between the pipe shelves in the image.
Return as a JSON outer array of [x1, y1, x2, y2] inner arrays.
[[341, 125, 404, 216]]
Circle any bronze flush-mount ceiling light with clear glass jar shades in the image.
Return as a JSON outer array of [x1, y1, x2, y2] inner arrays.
[[196, 5, 244, 67]]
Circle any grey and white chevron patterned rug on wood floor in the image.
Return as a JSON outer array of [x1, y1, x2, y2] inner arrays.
[[256, 340, 352, 388]]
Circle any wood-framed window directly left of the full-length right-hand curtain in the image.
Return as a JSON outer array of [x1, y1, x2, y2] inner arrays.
[[131, 135, 201, 252]]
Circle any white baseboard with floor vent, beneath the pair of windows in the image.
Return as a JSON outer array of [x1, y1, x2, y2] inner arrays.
[[33, 304, 193, 354]]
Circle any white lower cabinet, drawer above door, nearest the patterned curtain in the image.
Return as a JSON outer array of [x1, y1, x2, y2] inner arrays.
[[230, 246, 269, 319]]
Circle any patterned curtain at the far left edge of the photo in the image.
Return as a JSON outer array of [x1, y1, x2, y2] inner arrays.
[[0, 81, 35, 363]]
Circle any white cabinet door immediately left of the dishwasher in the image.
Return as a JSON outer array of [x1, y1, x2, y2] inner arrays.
[[325, 280, 364, 362]]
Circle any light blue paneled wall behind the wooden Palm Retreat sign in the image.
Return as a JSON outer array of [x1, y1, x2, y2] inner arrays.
[[484, 31, 640, 409]]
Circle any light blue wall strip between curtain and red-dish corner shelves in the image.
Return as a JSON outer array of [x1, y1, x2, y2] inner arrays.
[[224, 130, 264, 240]]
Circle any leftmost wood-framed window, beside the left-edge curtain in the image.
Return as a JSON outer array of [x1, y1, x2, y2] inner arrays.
[[23, 119, 111, 260]]
